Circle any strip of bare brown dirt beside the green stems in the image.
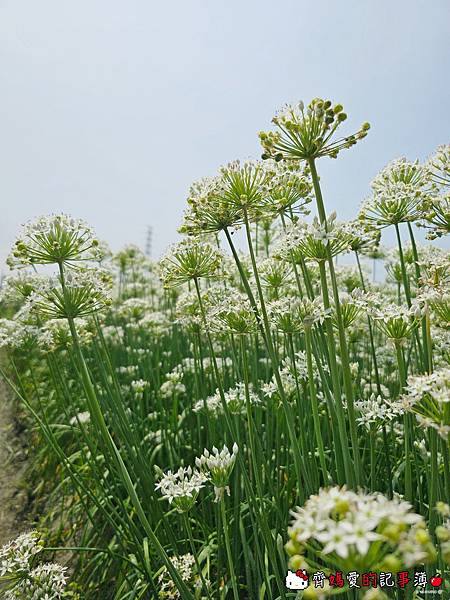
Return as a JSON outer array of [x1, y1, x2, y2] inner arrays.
[[0, 380, 27, 546]]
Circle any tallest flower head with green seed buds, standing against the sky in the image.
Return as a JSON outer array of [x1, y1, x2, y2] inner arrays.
[[259, 98, 370, 161]]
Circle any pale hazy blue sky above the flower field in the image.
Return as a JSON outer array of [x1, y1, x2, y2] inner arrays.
[[0, 0, 450, 265]]
